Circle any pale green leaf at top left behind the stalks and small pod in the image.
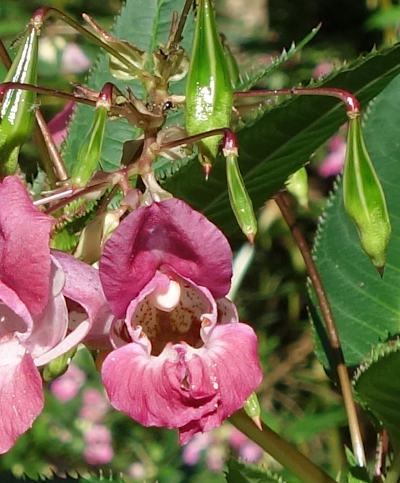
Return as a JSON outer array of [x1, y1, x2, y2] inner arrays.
[[63, 0, 193, 176]]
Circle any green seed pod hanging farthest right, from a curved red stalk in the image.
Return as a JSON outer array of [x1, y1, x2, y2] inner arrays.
[[343, 117, 391, 274]]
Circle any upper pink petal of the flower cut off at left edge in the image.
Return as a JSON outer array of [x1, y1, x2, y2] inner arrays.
[[0, 176, 52, 314]]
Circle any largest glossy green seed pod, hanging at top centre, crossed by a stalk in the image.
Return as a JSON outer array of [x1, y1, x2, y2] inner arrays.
[[185, 0, 233, 171]]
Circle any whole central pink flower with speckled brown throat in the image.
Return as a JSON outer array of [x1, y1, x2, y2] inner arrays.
[[99, 199, 262, 444]]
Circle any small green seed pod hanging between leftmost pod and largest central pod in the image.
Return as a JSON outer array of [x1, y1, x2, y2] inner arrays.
[[71, 83, 113, 187]]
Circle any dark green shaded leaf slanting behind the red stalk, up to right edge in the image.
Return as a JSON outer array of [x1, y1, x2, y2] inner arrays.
[[165, 45, 400, 234]]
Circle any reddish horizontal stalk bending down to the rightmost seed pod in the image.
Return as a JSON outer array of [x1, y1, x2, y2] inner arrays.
[[233, 87, 360, 114]]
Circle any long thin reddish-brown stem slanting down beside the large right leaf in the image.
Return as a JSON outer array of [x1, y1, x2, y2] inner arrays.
[[275, 193, 366, 466]]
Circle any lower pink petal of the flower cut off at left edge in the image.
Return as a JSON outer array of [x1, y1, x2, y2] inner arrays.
[[0, 337, 44, 453]]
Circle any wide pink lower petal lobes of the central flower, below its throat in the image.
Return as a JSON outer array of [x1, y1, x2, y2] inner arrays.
[[102, 323, 262, 444]]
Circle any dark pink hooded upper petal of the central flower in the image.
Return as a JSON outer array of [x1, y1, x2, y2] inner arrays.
[[100, 198, 232, 317]]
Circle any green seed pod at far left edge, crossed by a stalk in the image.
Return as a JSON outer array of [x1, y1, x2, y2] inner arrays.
[[0, 25, 39, 177]]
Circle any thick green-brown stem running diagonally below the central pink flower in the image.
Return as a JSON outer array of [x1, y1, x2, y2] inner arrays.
[[229, 409, 335, 483]]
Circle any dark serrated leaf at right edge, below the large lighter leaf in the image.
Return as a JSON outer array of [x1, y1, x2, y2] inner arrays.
[[354, 339, 400, 454]]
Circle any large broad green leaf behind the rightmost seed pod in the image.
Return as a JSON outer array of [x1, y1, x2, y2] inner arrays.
[[312, 76, 400, 367]]
